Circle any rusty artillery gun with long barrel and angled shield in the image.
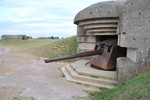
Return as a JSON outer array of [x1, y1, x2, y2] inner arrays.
[[45, 39, 126, 70]]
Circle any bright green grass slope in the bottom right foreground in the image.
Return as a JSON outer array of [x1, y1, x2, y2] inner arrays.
[[89, 71, 150, 100]]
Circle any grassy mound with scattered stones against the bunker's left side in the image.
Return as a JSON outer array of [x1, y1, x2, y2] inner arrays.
[[35, 36, 77, 62]]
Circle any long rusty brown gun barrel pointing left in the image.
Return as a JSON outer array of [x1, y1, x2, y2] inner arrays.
[[45, 49, 103, 63]]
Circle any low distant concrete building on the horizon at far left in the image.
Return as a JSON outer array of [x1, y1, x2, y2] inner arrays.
[[1, 35, 27, 40]]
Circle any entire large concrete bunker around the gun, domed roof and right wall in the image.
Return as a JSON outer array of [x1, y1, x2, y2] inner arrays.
[[74, 0, 150, 84]]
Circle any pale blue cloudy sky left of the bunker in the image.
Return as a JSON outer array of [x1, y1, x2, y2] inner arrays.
[[0, 0, 115, 38]]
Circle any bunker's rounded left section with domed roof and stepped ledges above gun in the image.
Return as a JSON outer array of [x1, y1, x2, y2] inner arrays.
[[74, 1, 126, 69]]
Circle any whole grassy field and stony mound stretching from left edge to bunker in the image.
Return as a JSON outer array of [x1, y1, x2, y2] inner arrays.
[[0, 36, 77, 62]]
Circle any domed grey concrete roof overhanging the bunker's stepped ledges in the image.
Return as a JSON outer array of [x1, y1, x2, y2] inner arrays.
[[74, 1, 125, 24]]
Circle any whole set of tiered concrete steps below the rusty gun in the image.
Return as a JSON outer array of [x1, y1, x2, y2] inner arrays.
[[61, 60, 118, 89]]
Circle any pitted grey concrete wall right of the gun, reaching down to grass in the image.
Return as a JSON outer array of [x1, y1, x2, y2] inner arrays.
[[118, 0, 150, 83]]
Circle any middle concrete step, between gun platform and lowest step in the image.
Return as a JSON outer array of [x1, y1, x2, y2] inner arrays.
[[65, 65, 117, 86]]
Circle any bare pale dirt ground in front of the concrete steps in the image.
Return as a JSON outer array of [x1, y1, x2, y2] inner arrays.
[[0, 46, 97, 100]]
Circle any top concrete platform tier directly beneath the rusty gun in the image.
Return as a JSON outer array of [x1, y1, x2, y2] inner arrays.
[[70, 60, 117, 81]]
